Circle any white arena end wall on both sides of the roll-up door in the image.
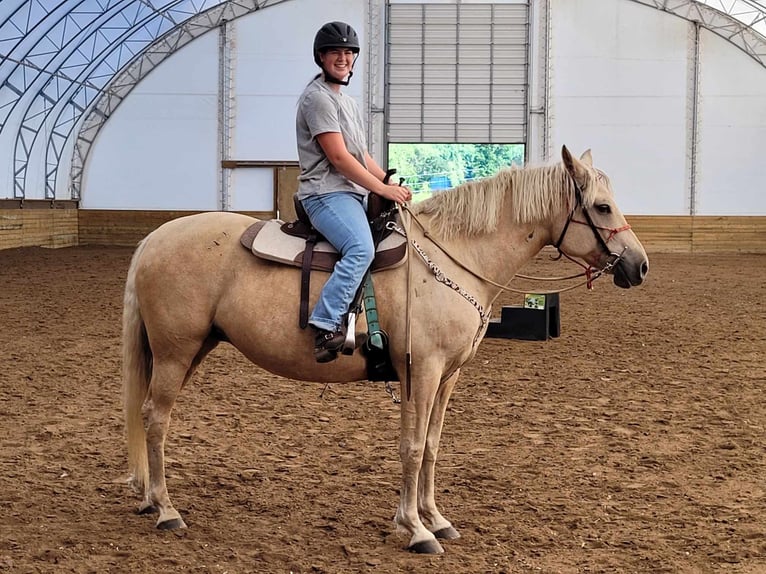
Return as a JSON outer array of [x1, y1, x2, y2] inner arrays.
[[81, 0, 766, 219]]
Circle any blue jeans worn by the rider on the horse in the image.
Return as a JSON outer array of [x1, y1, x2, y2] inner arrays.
[[302, 191, 375, 331]]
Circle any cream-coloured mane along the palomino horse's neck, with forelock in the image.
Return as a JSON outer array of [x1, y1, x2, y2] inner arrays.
[[412, 163, 595, 238]]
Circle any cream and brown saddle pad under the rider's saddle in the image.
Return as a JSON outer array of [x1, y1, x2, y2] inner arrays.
[[240, 219, 407, 273]]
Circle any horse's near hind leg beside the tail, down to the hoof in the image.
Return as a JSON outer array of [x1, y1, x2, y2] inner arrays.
[[141, 357, 194, 530]]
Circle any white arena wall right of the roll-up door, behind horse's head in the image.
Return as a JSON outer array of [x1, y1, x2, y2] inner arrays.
[[549, 0, 766, 215]]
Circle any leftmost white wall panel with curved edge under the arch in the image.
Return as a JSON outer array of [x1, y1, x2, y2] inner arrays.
[[80, 33, 218, 210]]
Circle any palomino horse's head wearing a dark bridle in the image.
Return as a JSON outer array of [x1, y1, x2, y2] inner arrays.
[[555, 146, 649, 289]]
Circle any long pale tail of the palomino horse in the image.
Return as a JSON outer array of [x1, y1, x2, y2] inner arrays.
[[122, 241, 152, 492]]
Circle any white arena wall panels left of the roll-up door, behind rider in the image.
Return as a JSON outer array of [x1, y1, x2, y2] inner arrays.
[[80, 0, 366, 211]]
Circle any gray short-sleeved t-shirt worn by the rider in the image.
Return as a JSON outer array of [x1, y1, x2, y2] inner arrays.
[[295, 77, 369, 199]]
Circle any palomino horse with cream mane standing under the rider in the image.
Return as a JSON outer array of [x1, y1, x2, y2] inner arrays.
[[123, 147, 648, 553]]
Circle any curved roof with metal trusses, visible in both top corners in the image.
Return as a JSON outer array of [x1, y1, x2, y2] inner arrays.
[[0, 0, 766, 199]]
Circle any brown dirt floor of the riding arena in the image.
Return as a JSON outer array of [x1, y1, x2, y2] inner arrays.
[[0, 248, 766, 574]]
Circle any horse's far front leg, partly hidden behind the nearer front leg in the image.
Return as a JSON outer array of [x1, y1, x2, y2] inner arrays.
[[418, 370, 460, 540]]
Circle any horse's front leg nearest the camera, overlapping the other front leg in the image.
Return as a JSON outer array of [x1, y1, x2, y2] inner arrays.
[[394, 377, 444, 554]]
